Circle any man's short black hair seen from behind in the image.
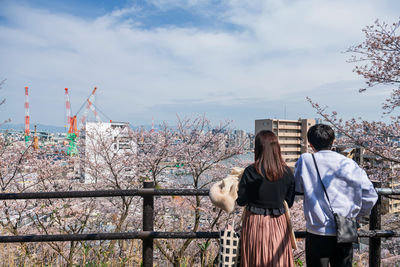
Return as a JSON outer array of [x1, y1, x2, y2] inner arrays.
[[307, 124, 335, 151]]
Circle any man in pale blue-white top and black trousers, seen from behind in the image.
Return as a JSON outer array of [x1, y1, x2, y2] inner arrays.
[[295, 124, 378, 267]]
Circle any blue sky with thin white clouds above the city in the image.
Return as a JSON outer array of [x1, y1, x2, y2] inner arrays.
[[0, 0, 400, 131]]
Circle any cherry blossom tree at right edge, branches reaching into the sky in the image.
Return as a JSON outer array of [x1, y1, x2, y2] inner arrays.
[[307, 20, 400, 264]]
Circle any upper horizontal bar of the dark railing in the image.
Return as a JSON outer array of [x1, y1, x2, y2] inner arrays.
[[0, 188, 400, 200]]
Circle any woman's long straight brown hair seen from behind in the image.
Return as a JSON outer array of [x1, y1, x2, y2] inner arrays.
[[254, 130, 286, 181]]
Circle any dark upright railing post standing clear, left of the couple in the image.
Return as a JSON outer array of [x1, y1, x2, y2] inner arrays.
[[142, 182, 154, 267]]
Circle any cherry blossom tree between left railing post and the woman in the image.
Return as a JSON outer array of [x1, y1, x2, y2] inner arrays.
[[150, 116, 244, 266]]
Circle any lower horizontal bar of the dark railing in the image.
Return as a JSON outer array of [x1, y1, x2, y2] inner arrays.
[[0, 230, 400, 243]]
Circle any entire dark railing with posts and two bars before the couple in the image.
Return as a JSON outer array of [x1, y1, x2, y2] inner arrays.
[[0, 182, 400, 267]]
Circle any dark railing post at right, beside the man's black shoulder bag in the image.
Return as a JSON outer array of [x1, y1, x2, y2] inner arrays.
[[369, 182, 382, 267]]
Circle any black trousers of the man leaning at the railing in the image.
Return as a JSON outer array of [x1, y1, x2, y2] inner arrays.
[[306, 233, 353, 267]]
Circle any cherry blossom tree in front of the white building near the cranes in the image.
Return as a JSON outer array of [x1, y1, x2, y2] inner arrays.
[[79, 124, 142, 264]]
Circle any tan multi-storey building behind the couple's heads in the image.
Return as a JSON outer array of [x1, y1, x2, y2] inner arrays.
[[254, 119, 315, 167]]
